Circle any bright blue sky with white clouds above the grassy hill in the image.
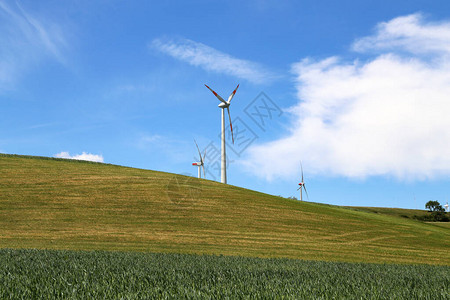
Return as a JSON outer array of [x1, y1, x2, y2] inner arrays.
[[0, 0, 450, 208]]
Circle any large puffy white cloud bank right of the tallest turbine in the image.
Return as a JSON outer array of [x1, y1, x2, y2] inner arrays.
[[245, 15, 450, 180]]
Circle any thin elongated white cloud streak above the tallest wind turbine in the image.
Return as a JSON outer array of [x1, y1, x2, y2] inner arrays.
[[150, 39, 275, 83]]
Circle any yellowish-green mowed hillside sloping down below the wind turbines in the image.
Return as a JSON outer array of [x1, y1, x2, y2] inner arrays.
[[0, 155, 450, 265]]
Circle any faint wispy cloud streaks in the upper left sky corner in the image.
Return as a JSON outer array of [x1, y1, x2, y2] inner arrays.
[[0, 0, 67, 90]]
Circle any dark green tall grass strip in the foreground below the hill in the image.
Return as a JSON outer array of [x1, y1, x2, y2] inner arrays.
[[0, 249, 450, 300]]
